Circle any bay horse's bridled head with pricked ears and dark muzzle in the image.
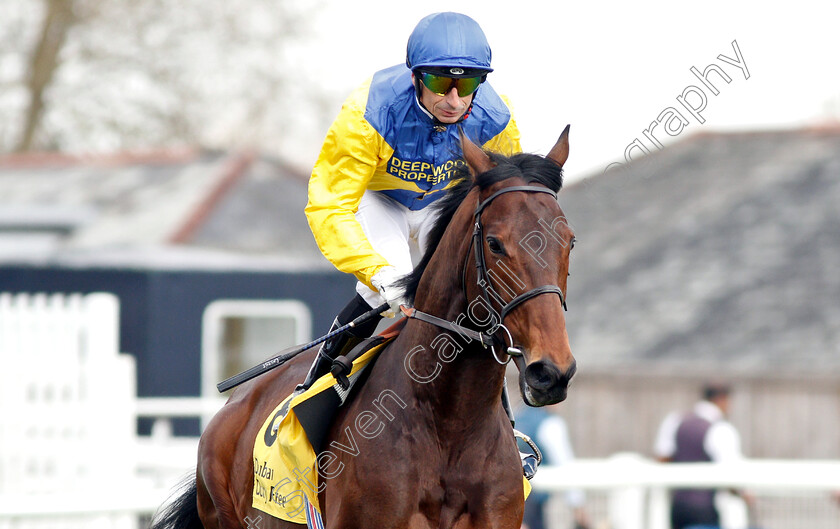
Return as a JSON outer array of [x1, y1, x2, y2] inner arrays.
[[462, 126, 575, 406]]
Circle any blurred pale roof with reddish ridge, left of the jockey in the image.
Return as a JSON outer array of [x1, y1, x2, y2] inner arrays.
[[0, 149, 331, 269]]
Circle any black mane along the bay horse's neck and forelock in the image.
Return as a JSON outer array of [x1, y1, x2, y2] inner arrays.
[[401, 153, 563, 302]]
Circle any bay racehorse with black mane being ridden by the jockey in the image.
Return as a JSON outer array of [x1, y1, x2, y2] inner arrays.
[[152, 126, 575, 529]]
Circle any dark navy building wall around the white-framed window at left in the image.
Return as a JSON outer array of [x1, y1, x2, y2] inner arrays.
[[0, 267, 355, 397]]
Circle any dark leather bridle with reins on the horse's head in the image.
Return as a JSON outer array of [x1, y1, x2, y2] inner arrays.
[[403, 185, 567, 365]]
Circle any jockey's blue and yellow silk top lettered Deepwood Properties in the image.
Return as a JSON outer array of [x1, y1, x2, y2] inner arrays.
[[306, 65, 522, 287]]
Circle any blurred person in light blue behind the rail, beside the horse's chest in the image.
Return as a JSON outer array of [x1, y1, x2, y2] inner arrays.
[[516, 404, 591, 529]]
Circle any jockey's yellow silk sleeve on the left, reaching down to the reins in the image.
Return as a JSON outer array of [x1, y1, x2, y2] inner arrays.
[[305, 85, 388, 288]]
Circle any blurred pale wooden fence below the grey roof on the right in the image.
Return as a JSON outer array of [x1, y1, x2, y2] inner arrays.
[[559, 366, 840, 459]]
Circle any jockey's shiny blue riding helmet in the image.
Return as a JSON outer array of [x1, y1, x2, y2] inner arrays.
[[405, 12, 493, 77]]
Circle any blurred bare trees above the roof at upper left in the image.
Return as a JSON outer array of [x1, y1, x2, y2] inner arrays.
[[0, 0, 332, 163]]
